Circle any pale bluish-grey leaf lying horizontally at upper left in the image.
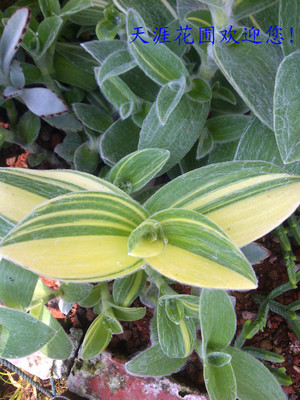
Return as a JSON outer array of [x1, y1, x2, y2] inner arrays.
[[20, 88, 68, 117]]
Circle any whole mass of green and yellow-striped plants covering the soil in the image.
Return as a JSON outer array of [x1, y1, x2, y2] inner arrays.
[[0, 0, 300, 400]]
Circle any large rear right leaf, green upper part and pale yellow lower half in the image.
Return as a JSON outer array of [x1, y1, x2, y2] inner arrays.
[[145, 161, 300, 247]]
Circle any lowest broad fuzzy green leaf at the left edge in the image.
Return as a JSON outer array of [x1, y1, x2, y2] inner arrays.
[[0, 307, 55, 358]]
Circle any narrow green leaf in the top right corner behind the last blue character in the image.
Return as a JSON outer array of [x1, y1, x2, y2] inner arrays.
[[278, 0, 300, 56]]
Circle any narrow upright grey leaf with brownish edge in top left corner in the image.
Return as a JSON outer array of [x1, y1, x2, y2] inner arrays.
[[0, 7, 30, 75]]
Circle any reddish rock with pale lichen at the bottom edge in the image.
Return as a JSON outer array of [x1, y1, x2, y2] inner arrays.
[[67, 351, 208, 400]]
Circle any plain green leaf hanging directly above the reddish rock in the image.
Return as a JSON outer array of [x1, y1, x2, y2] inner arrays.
[[125, 344, 187, 376]]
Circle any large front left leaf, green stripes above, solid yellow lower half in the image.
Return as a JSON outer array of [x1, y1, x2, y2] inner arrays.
[[0, 192, 148, 281]]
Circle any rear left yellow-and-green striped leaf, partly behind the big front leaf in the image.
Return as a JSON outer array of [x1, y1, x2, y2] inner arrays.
[[0, 168, 126, 228]]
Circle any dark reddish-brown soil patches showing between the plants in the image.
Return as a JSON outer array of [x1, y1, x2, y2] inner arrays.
[[0, 119, 300, 400]]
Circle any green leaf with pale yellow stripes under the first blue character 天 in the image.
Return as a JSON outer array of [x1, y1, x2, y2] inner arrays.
[[127, 9, 189, 85]]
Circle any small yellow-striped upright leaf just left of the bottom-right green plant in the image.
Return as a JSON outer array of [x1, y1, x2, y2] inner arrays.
[[157, 296, 196, 358]]
